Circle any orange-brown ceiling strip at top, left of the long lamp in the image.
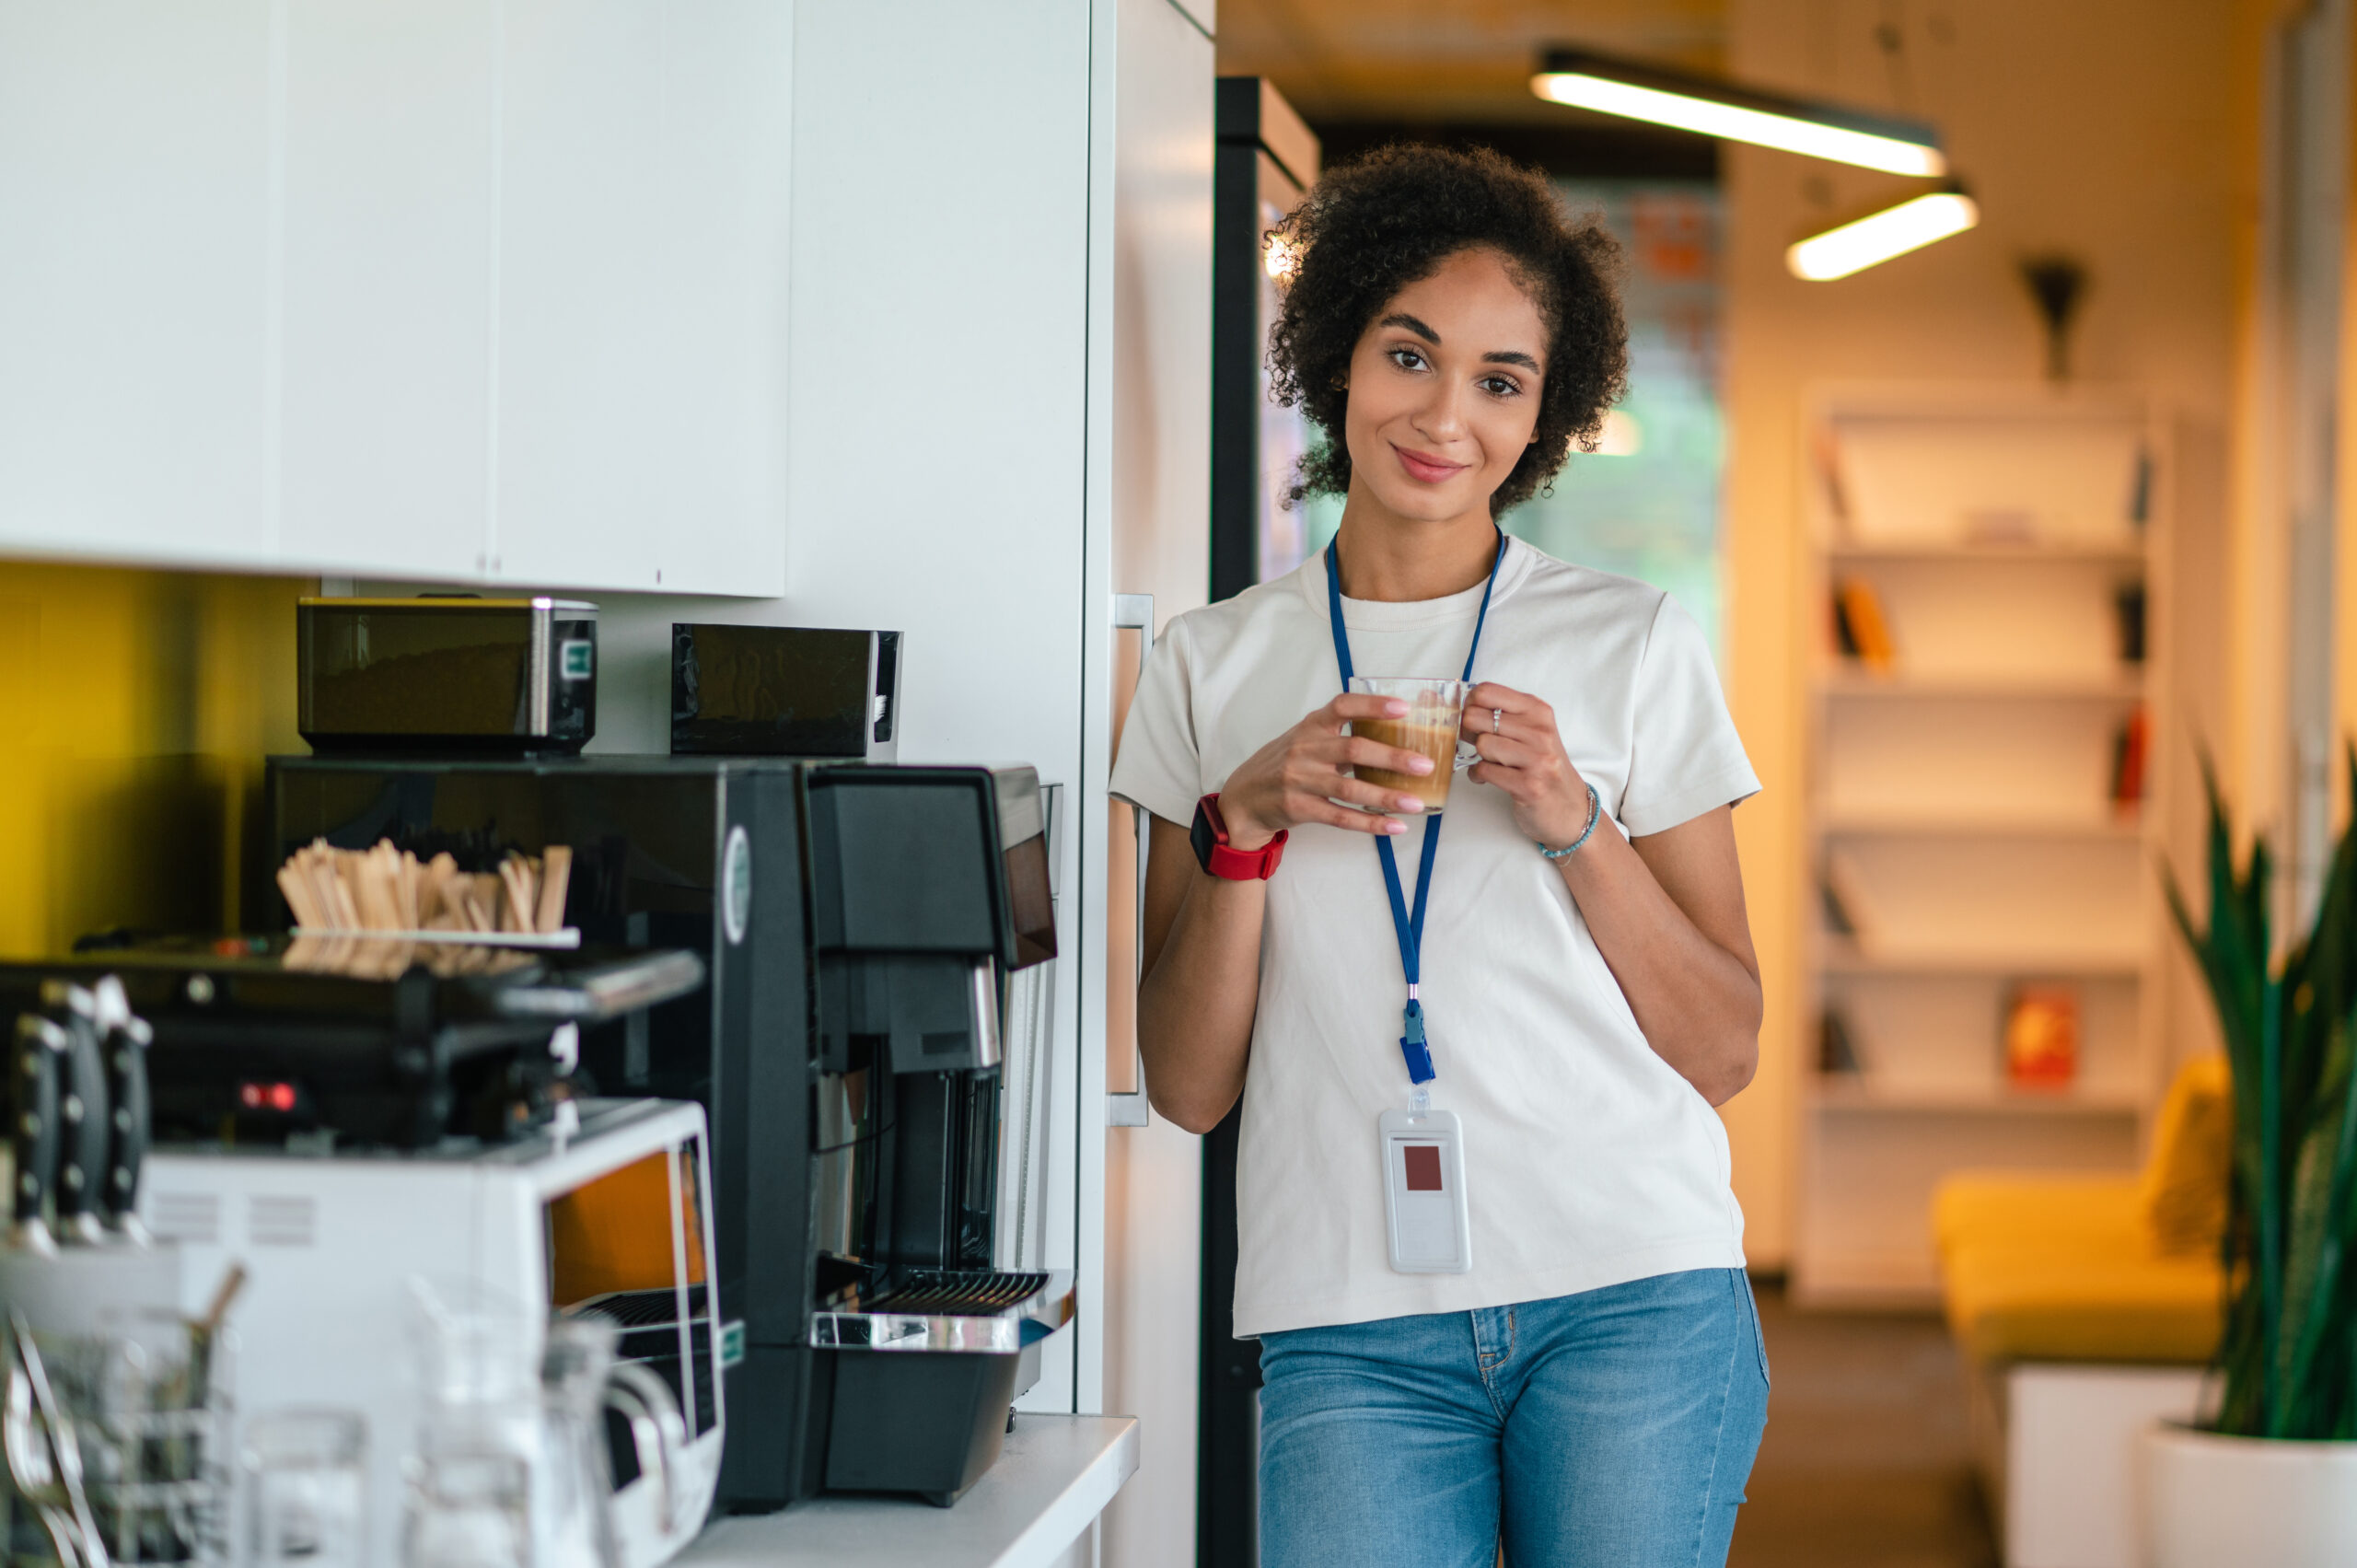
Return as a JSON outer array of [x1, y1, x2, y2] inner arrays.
[[1219, 0, 1725, 125]]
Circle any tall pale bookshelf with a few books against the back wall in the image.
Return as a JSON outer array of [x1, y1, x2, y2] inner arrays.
[[1792, 387, 2168, 1307]]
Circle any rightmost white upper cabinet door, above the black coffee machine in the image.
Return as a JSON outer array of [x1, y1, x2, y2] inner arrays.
[[490, 0, 792, 594]]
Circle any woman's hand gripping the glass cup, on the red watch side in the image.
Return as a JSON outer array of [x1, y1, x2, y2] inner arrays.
[[1219, 693, 1433, 849]]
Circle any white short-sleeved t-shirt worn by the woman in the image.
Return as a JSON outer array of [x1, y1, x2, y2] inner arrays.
[[1112, 540, 1760, 1334]]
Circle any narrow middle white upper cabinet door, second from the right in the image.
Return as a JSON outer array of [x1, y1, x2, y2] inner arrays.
[[278, 0, 497, 575]]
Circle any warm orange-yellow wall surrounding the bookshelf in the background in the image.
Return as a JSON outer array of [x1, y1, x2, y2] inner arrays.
[[1723, 0, 2260, 1266]]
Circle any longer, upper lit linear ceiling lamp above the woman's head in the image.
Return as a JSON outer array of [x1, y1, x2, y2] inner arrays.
[[1529, 50, 1947, 180]]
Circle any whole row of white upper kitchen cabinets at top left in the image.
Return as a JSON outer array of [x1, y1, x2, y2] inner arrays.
[[0, 0, 792, 594]]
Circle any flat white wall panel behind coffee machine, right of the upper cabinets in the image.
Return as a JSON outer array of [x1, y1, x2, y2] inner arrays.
[[594, 0, 1103, 1410]]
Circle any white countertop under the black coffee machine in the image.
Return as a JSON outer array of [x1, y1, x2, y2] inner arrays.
[[672, 1412, 1138, 1568]]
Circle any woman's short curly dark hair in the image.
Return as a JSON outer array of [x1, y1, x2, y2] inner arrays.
[[1268, 144, 1629, 517]]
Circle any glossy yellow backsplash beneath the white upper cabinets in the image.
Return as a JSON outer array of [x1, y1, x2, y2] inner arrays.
[[0, 561, 308, 955]]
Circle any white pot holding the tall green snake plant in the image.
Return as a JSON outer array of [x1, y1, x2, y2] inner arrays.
[[2140, 1422, 2357, 1568]]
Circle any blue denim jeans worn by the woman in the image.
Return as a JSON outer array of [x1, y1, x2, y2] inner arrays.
[[1261, 1269, 1768, 1568]]
